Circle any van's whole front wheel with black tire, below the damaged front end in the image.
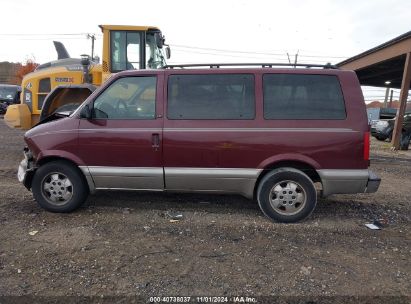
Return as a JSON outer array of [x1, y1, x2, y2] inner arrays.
[[31, 161, 89, 213]]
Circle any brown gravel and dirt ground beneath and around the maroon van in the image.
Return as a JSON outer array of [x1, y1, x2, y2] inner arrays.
[[0, 120, 411, 303]]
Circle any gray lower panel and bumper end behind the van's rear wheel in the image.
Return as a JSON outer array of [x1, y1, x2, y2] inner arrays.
[[317, 169, 381, 197]]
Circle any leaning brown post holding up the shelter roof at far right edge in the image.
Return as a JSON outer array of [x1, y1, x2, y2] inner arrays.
[[391, 53, 411, 150]]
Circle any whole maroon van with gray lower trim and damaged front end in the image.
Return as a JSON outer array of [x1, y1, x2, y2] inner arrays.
[[18, 66, 380, 222]]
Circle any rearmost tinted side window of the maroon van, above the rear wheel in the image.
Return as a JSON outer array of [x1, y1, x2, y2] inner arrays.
[[263, 74, 346, 119]]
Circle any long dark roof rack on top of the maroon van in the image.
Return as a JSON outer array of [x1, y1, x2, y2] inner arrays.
[[164, 63, 338, 69]]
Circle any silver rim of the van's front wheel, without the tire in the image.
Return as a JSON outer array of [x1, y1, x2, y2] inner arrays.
[[41, 172, 73, 206]]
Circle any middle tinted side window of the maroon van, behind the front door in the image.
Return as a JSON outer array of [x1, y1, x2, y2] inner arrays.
[[167, 74, 255, 119]]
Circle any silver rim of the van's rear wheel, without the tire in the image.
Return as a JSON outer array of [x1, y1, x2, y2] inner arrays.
[[269, 180, 307, 215]]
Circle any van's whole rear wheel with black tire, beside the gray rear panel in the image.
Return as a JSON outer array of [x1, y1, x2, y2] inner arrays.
[[257, 167, 317, 223]]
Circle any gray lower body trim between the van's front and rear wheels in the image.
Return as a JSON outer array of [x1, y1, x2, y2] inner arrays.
[[80, 166, 262, 198]]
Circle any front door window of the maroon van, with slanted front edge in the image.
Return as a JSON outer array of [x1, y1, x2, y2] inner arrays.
[[93, 76, 157, 119]]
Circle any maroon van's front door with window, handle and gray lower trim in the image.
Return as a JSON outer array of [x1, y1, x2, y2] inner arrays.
[[79, 72, 164, 190]]
